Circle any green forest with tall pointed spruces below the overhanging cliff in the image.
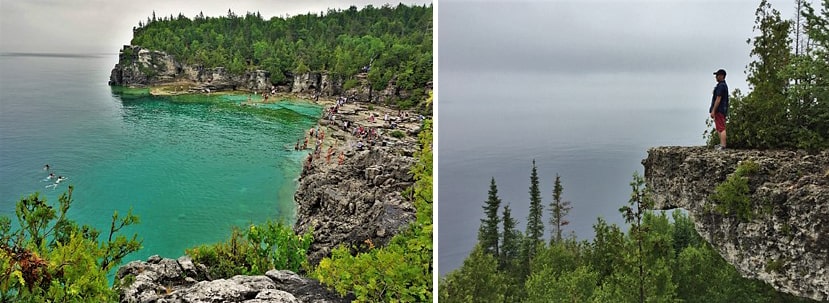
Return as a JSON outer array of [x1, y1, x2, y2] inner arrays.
[[438, 167, 811, 303]]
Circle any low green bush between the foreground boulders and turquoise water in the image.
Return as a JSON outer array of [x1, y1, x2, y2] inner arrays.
[[186, 221, 314, 279]]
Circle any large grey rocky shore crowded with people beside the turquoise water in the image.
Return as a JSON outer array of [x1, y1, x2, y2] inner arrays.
[[294, 103, 420, 264]]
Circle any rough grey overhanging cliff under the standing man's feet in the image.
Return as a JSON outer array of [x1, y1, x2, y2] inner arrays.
[[642, 147, 829, 301]]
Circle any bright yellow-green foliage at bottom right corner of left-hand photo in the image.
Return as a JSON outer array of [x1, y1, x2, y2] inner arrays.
[[311, 120, 434, 302]]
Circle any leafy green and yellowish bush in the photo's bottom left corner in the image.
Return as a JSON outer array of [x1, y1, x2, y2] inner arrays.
[[0, 186, 141, 302]]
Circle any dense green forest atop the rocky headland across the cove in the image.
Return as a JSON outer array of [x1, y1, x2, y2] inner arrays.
[[131, 4, 432, 99]]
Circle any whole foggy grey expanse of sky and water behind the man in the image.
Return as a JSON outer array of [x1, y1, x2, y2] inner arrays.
[[438, 0, 794, 275]]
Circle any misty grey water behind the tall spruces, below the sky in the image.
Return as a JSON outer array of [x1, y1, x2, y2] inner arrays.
[[438, 72, 709, 275]]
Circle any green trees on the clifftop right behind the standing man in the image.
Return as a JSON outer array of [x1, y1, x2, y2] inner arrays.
[[704, 0, 829, 150]]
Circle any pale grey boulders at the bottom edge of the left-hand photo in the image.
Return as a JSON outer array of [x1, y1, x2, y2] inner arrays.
[[115, 255, 350, 303]]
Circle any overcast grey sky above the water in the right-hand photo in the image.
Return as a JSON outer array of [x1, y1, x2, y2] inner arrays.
[[438, 0, 794, 97]]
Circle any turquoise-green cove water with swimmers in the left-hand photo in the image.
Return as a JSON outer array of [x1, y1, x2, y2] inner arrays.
[[0, 54, 320, 259]]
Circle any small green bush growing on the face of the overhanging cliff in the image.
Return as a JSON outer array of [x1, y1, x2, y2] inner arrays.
[[711, 160, 760, 222]]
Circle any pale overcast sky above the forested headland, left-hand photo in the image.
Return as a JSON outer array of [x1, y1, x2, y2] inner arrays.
[[0, 0, 431, 53]]
